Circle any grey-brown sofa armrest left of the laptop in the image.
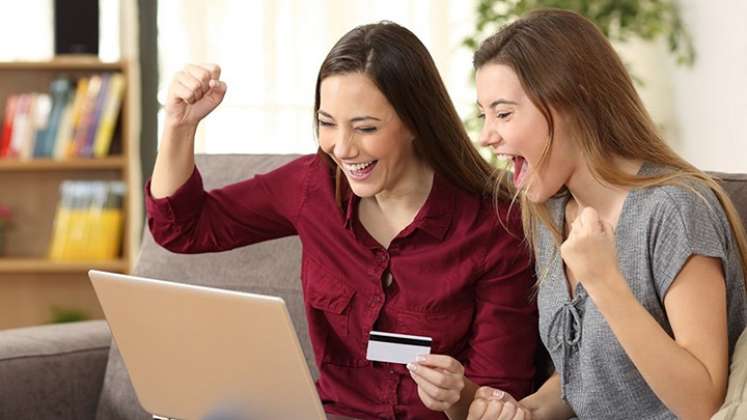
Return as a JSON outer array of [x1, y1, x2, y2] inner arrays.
[[0, 321, 111, 419]]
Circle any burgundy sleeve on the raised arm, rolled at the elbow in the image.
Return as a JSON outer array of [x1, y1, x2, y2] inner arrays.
[[145, 155, 315, 253]]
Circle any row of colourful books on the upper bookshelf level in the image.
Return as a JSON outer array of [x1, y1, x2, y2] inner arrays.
[[0, 73, 125, 160]]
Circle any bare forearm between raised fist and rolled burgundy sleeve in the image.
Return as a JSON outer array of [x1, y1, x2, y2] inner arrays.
[[150, 124, 197, 198]]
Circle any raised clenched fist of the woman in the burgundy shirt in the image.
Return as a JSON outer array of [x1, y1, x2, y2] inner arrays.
[[164, 64, 226, 127]]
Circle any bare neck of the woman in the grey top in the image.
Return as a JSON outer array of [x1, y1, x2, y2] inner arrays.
[[566, 158, 642, 226]]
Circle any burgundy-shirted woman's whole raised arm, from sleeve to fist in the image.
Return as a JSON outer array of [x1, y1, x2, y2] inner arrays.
[[146, 65, 310, 253]]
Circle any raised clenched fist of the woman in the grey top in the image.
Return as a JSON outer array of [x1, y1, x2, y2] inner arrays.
[[560, 207, 619, 292]]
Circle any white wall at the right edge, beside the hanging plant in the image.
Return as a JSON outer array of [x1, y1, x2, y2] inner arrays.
[[673, 0, 747, 172]]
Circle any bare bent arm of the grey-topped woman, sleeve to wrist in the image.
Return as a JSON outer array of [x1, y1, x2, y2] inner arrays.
[[589, 256, 728, 419]]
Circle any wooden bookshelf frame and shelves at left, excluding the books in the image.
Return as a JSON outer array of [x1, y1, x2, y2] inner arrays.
[[0, 57, 139, 329]]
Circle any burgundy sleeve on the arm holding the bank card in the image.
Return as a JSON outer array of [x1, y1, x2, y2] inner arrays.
[[465, 208, 539, 399]]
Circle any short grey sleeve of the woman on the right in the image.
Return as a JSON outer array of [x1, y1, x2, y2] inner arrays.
[[649, 187, 728, 302]]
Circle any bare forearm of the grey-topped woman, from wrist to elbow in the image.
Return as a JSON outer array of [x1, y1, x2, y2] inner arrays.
[[589, 277, 724, 419]]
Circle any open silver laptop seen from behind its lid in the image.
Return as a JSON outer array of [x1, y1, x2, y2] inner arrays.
[[88, 270, 326, 420]]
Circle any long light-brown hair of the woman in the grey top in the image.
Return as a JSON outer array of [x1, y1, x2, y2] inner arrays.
[[474, 9, 747, 278]]
